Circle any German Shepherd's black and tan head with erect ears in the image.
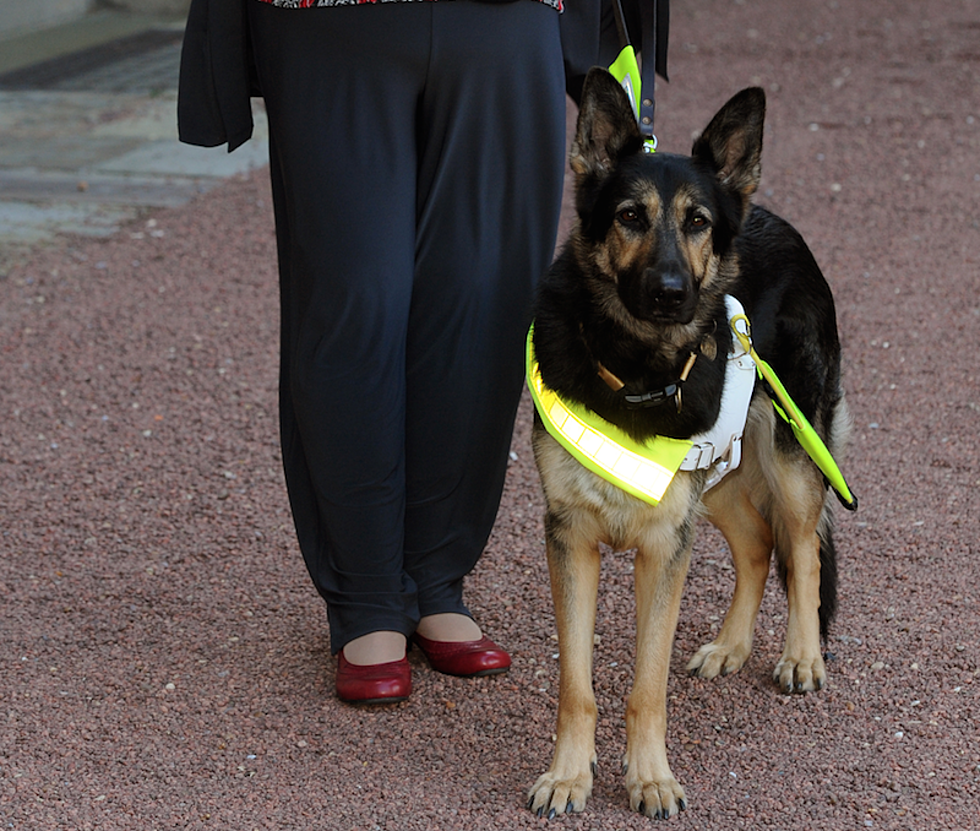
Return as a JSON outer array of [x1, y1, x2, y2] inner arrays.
[[570, 68, 765, 337]]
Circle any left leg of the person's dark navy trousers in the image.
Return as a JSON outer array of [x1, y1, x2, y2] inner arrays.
[[249, 2, 429, 652]]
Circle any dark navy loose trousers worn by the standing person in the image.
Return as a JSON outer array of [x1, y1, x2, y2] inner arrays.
[[249, 0, 565, 652]]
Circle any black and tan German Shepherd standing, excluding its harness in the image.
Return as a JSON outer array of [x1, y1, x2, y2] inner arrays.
[[528, 68, 849, 818]]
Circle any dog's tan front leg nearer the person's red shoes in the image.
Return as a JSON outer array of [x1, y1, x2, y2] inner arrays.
[[528, 511, 600, 818]]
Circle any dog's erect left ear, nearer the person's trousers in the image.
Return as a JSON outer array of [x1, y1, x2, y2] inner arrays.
[[569, 66, 643, 177]]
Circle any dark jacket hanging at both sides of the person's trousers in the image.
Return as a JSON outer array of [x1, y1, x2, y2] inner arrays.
[[177, 0, 668, 153]]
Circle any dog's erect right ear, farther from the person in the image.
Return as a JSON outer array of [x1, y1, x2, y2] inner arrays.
[[691, 87, 766, 198]]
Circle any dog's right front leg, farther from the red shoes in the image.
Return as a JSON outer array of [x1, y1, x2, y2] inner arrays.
[[624, 534, 691, 819]]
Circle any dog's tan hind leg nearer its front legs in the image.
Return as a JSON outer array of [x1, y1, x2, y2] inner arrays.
[[687, 472, 773, 678]]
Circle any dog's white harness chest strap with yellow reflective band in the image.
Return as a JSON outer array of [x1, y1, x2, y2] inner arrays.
[[527, 295, 756, 505]]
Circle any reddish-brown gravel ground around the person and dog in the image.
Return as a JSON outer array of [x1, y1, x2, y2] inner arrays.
[[0, 0, 980, 831]]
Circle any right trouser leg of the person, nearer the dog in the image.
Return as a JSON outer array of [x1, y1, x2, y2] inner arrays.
[[405, 2, 565, 639]]
